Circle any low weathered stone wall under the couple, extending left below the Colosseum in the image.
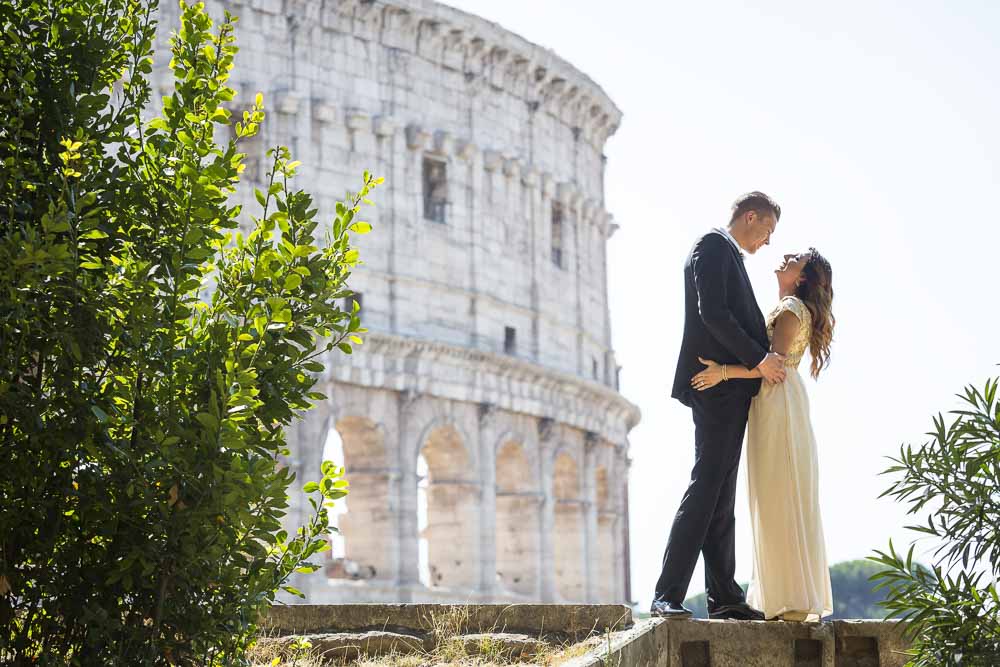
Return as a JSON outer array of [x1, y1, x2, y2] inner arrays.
[[262, 604, 910, 667]]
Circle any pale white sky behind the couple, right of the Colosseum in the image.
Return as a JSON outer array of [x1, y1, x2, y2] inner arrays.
[[450, 0, 1000, 607]]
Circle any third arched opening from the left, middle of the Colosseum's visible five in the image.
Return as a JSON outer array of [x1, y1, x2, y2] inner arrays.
[[496, 440, 539, 595]]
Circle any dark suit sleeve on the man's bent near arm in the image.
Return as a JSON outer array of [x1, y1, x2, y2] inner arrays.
[[691, 234, 767, 368]]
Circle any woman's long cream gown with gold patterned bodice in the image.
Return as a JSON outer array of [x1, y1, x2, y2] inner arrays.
[[747, 297, 833, 620]]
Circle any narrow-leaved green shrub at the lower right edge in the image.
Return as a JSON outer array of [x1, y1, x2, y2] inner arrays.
[[872, 379, 1000, 667]]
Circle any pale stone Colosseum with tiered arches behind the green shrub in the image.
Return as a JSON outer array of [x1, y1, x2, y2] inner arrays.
[[154, 0, 639, 603]]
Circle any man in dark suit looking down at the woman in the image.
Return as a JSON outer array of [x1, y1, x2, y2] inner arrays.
[[651, 192, 785, 620]]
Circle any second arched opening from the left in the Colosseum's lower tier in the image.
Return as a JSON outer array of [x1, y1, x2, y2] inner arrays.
[[418, 425, 479, 589]]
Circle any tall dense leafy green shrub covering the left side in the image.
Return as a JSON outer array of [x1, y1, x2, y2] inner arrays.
[[0, 0, 380, 665]]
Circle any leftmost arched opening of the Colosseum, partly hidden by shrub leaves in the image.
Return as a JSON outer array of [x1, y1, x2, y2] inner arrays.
[[327, 416, 388, 580]]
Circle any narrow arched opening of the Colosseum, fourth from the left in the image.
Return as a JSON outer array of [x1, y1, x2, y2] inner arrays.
[[552, 452, 586, 602]]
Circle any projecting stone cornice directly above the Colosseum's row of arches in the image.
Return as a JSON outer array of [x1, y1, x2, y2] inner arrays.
[[325, 333, 640, 445]]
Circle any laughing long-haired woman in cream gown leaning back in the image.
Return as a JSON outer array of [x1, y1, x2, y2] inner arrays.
[[691, 248, 835, 621]]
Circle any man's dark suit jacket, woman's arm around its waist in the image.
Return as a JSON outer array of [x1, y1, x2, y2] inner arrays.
[[672, 231, 770, 406]]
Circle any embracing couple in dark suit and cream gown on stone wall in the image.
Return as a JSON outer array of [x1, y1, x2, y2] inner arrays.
[[651, 192, 834, 621]]
